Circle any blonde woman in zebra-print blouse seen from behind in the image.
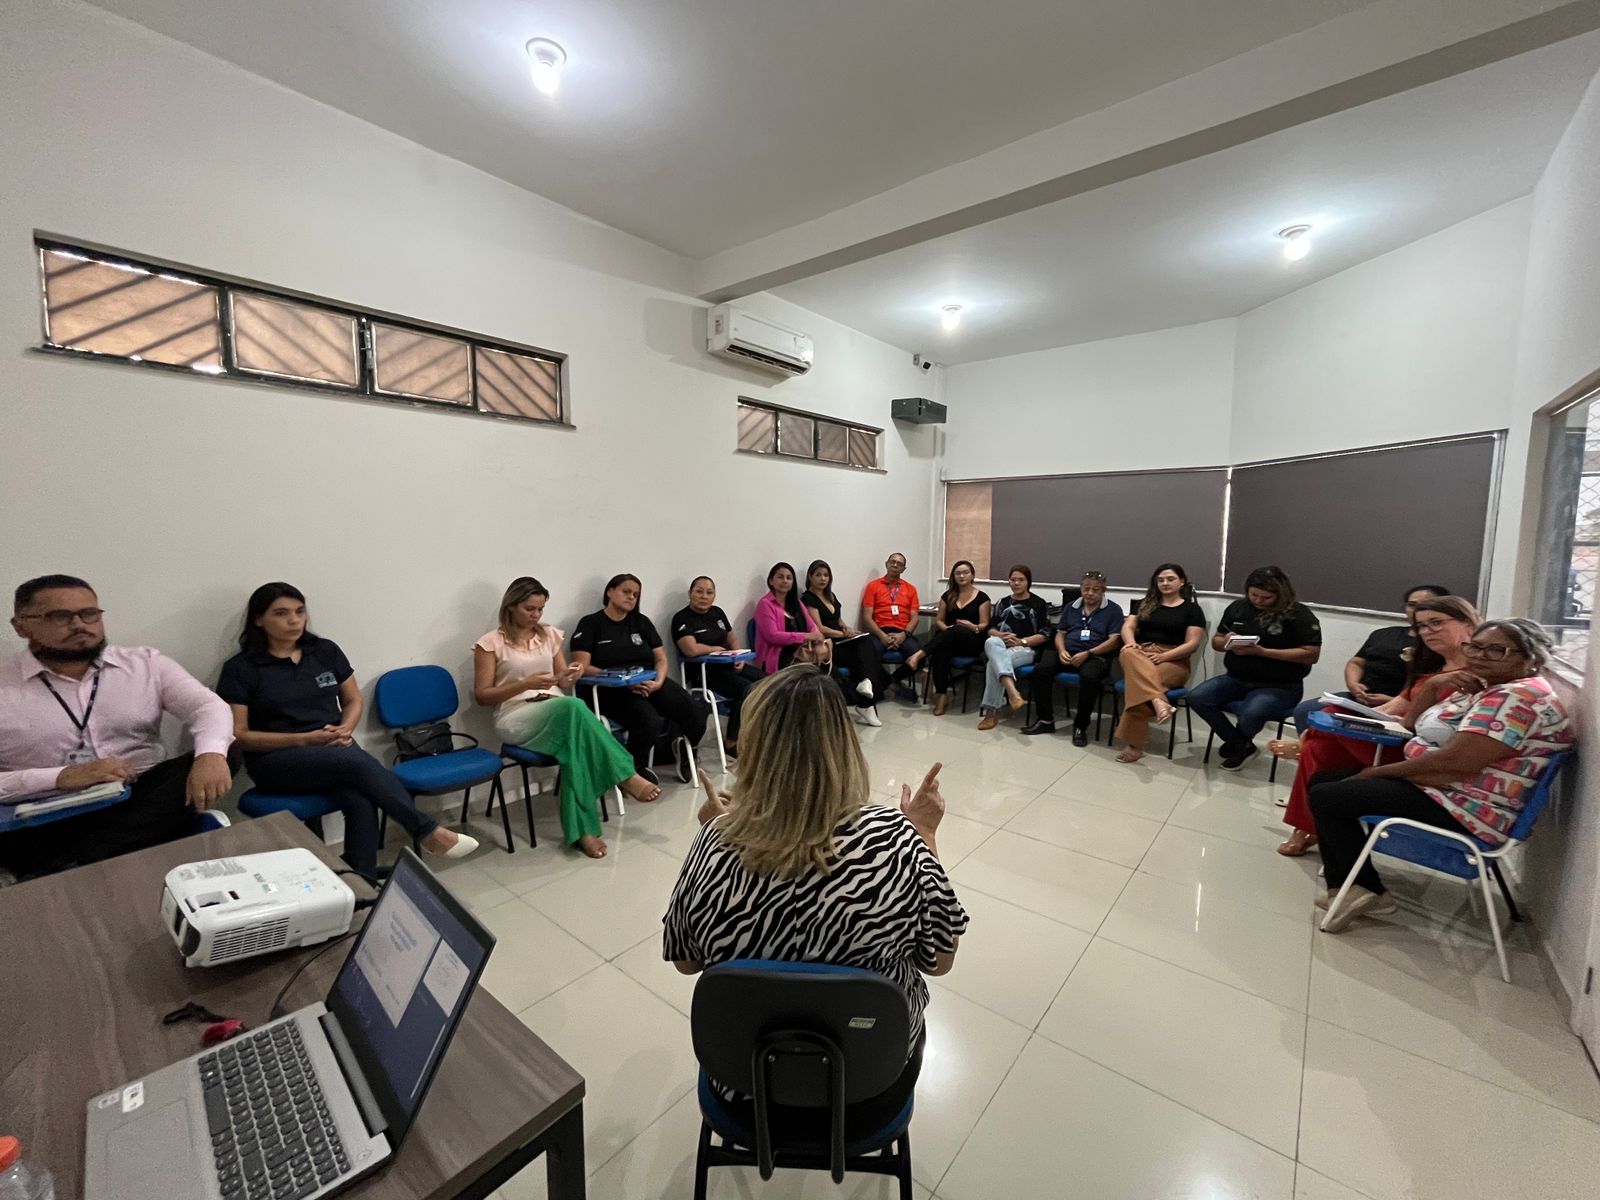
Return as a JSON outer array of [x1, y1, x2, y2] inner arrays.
[[662, 664, 966, 1072]]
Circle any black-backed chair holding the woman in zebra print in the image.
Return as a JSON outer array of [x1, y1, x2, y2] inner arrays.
[[690, 958, 922, 1200]]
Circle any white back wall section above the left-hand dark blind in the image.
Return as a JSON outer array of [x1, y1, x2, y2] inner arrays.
[[942, 320, 1235, 478]]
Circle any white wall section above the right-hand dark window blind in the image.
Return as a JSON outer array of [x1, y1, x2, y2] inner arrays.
[[1229, 197, 1531, 462]]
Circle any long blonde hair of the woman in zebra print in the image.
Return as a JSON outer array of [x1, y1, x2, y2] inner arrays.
[[717, 664, 872, 878]]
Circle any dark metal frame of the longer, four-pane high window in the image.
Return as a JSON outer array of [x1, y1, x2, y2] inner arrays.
[[30, 230, 576, 429]]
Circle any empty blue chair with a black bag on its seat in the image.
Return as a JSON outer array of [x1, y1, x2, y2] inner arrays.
[[373, 664, 512, 854]]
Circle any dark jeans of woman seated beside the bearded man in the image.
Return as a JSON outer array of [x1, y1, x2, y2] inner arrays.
[[245, 746, 438, 874]]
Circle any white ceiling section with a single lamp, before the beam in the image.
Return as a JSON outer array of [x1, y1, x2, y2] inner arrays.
[[84, 0, 1371, 258]]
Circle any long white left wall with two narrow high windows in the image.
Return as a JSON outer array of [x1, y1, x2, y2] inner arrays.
[[0, 0, 933, 752]]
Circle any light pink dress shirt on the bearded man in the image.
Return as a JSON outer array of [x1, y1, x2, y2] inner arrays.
[[0, 646, 234, 800]]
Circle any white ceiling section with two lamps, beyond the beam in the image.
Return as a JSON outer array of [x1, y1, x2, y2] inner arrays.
[[778, 34, 1600, 363]]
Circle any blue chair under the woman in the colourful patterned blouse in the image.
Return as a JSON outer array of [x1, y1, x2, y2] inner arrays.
[[1322, 750, 1574, 984]]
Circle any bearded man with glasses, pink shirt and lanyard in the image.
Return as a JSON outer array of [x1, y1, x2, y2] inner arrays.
[[0, 574, 234, 875]]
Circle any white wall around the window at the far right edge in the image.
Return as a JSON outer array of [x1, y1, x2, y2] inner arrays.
[[1502, 63, 1600, 1024]]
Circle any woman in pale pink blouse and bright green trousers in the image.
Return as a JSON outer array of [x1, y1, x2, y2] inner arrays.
[[472, 576, 661, 858]]
